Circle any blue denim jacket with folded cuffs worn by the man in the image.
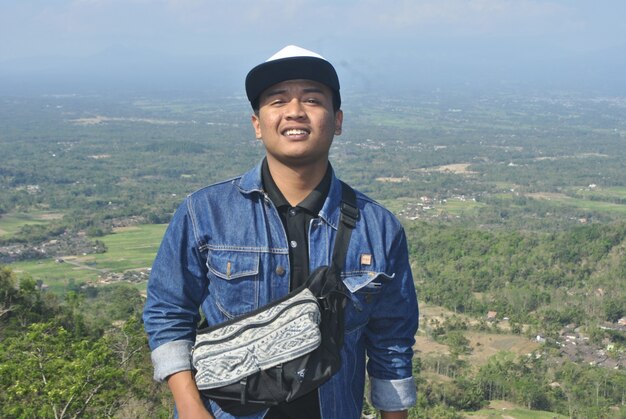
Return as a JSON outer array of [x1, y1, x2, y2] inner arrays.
[[144, 160, 418, 419]]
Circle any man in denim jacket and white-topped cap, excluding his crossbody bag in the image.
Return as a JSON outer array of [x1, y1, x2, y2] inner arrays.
[[144, 46, 418, 419]]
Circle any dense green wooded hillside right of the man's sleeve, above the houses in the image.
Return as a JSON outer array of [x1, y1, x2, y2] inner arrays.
[[407, 222, 626, 330]]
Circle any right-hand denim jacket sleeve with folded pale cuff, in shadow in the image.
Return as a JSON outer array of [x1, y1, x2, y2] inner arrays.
[[365, 229, 419, 411]]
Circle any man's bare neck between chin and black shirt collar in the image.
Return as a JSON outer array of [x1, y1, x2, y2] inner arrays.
[[267, 157, 328, 206]]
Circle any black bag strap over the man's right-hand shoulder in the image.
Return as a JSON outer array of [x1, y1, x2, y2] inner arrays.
[[331, 182, 359, 277]]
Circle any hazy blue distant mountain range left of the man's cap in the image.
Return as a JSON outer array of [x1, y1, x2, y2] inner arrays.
[[0, 46, 245, 94]]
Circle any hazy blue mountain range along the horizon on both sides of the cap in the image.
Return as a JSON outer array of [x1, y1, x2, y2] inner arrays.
[[0, 41, 626, 95]]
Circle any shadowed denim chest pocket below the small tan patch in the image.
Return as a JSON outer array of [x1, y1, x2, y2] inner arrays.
[[343, 272, 392, 333]]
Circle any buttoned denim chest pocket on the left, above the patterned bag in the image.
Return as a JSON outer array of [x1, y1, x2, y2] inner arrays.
[[207, 249, 260, 318]]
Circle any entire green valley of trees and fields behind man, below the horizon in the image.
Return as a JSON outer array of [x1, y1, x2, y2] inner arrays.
[[0, 89, 626, 418]]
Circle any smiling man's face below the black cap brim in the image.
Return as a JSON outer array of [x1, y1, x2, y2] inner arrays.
[[252, 80, 343, 167]]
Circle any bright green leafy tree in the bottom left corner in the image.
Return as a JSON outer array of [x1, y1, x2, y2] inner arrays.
[[0, 322, 128, 419]]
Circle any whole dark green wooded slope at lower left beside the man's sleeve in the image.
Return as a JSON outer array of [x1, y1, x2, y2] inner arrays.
[[0, 268, 168, 418]]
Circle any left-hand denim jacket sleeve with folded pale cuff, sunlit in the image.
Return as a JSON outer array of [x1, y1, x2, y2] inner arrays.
[[143, 198, 207, 381]]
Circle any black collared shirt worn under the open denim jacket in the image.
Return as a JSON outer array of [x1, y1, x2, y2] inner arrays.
[[261, 160, 331, 419]]
